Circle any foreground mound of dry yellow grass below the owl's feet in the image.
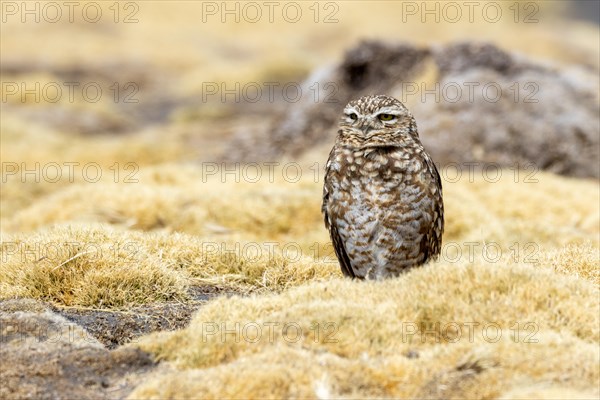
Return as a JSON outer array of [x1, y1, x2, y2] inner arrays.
[[131, 262, 600, 398]]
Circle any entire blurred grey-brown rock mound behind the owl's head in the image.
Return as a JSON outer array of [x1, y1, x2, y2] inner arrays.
[[226, 41, 600, 178]]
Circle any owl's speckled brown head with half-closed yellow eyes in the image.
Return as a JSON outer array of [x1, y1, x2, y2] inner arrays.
[[338, 95, 419, 148]]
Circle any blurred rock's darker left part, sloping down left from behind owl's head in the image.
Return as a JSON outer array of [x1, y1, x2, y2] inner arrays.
[[226, 41, 429, 161]]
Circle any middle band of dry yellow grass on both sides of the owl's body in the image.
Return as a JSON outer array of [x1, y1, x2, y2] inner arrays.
[[0, 164, 600, 307]]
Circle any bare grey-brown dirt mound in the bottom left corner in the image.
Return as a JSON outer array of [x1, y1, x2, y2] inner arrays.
[[0, 300, 156, 399]]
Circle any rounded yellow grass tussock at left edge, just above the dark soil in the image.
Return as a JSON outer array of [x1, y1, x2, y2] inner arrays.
[[0, 226, 188, 308]]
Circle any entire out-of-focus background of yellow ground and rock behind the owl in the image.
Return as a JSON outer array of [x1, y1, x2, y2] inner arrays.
[[0, 0, 600, 222]]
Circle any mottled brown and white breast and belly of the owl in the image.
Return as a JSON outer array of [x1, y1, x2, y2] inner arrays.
[[326, 144, 436, 276]]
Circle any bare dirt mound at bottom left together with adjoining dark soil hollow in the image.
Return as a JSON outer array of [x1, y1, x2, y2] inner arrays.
[[0, 287, 239, 399]]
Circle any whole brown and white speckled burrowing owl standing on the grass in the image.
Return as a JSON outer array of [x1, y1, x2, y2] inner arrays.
[[322, 96, 444, 279]]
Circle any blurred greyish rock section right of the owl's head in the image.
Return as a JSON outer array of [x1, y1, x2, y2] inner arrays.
[[412, 43, 600, 178]]
